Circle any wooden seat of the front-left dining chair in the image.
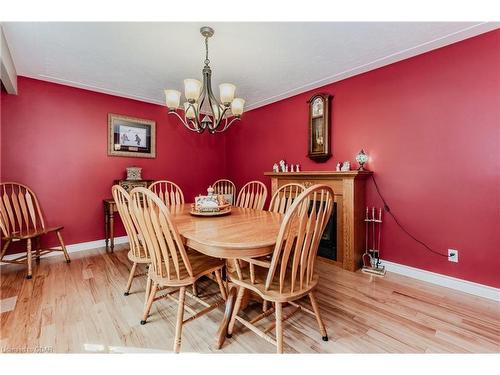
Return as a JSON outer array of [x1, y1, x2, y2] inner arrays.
[[149, 249, 225, 287]]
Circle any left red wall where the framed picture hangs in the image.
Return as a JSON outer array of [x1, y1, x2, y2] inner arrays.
[[1, 77, 225, 250]]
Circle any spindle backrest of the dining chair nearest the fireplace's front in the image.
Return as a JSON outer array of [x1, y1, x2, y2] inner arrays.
[[265, 185, 334, 293]]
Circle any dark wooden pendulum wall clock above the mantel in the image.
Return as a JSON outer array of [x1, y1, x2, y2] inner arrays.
[[307, 94, 332, 161]]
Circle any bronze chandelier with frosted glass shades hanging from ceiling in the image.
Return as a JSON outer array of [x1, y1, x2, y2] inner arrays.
[[165, 26, 245, 134]]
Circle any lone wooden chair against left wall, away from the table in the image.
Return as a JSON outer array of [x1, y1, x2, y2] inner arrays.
[[0, 182, 71, 279]]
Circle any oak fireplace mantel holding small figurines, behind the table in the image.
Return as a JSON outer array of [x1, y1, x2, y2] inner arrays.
[[264, 171, 372, 271]]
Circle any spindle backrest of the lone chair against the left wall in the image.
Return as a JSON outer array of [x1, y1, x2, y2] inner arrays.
[[0, 182, 45, 237]]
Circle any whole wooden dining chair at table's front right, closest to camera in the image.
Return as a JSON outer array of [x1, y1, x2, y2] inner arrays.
[[227, 185, 334, 353]]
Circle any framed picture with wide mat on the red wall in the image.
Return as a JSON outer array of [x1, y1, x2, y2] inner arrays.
[[108, 113, 156, 158]]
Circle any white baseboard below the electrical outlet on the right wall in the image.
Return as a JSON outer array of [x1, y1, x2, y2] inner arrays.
[[381, 260, 500, 302]]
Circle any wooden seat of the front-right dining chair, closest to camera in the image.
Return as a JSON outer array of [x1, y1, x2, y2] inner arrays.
[[228, 267, 319, 302]]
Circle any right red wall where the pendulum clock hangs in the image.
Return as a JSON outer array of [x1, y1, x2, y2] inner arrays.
[[226, 30, 500, 287]]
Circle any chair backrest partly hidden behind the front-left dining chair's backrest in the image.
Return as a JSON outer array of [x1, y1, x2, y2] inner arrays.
[[111, 185, 148, 258]]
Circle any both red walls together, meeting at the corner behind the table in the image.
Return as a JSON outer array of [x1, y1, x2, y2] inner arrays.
[[1, 30, 500, 287]]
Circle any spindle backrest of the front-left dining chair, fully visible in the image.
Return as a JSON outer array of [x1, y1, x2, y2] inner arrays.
[[130, 187, 193, 282]]
